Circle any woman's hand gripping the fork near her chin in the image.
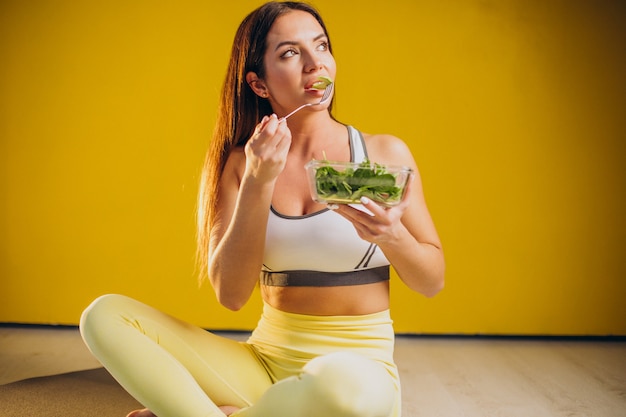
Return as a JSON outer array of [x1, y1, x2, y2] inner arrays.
[[244, 114, 291, 182]]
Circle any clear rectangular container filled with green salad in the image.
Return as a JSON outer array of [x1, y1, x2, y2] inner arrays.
[[304, 160, 413, 207]]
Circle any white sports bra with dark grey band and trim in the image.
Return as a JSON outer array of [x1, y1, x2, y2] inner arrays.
[[261, 126, 389, 286]]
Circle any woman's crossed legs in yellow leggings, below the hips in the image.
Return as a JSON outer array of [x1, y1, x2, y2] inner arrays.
[[80, 295, 399, 417]]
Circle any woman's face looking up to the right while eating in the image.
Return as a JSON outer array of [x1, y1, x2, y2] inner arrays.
[[263, 10, 336, 115]]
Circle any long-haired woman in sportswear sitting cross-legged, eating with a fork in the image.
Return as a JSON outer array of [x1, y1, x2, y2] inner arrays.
[[81, 2, 444, 417]]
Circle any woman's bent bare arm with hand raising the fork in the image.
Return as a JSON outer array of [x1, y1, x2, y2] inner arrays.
[[208, 116, 291, 310]]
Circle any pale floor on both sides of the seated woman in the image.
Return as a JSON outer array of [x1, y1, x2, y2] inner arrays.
[[0, 326, 626, 417]]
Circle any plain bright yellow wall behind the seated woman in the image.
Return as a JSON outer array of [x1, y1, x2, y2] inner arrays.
[[0, 0, 626, 335]]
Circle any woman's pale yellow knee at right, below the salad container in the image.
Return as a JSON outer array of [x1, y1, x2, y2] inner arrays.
[[303, 352, 396, 417]]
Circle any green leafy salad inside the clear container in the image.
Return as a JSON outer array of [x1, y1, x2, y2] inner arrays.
[[315, 160, 403, 204]]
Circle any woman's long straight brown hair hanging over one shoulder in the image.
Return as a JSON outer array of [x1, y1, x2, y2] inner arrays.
[[197, 1, 332, 279]]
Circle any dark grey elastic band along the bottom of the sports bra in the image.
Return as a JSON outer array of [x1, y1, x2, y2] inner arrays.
[[261, 265, 389, 287]]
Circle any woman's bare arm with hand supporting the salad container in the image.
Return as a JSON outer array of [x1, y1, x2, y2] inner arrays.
[[337, 136, 445, 297]]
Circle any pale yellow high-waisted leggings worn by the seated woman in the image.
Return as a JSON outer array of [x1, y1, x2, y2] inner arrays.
[[80, 295, 400, 417]]
